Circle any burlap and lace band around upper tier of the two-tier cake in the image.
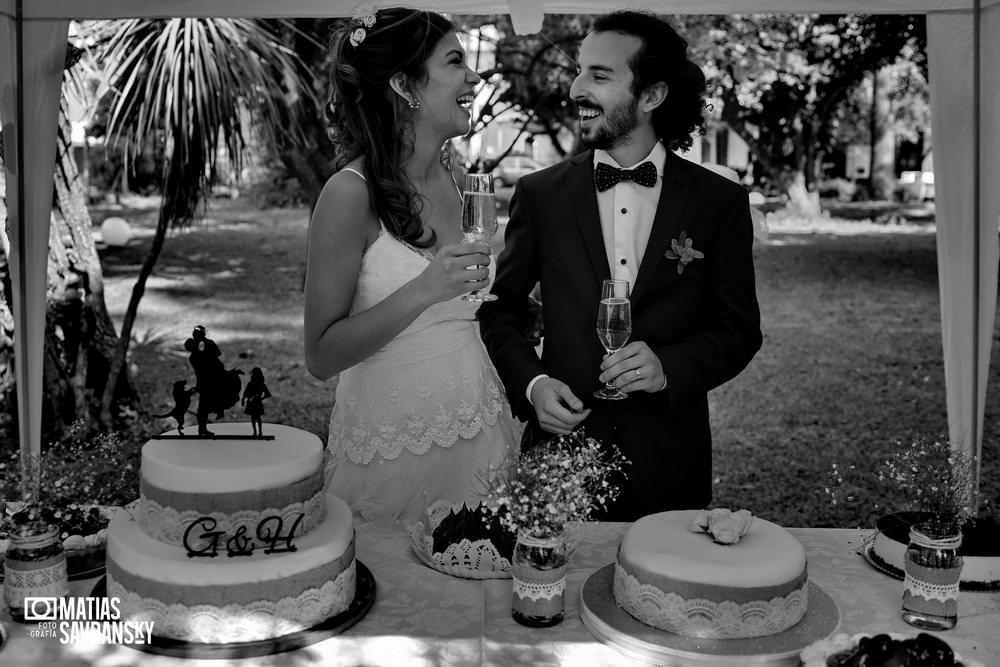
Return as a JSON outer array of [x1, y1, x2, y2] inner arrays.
[[138, 469, 326, 546]]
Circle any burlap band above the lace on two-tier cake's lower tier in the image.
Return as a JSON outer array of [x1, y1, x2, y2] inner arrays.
[[107, 542, 354, 607]]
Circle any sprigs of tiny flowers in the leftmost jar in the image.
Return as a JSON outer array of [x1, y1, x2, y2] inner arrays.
[[0, 422, 139, 555]]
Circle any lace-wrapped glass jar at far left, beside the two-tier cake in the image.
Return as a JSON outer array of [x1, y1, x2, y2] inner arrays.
[[3, 526, 69, 623]]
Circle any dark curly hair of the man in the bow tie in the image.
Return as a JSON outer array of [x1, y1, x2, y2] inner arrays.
[[592, 10, 706, 151]]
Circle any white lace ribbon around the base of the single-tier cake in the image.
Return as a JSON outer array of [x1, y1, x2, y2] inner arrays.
[[614, 564, 808, 639]]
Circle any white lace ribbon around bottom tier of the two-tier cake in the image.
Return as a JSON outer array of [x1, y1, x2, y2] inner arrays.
[[107, 561, 357, 644]]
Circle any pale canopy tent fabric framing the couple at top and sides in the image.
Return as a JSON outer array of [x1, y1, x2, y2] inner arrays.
[[0, 0, 1000, 496]]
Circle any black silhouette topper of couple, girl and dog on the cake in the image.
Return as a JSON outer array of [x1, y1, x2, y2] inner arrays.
[[154, 324, 274, 440]]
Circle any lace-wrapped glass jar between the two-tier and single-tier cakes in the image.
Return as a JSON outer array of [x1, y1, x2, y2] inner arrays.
[[511, 531, 569, 628]]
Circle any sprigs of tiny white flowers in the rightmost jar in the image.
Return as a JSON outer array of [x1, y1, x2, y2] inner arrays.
[[826, 438, 977, 535]]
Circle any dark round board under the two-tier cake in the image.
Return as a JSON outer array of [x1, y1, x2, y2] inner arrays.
[[91, 560, 375, 660]]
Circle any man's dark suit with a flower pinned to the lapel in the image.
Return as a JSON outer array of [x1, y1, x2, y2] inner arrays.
[[479, 151, 762, 521]]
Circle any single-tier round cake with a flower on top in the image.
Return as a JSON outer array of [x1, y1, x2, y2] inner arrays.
[[614, 510, 809, 639]]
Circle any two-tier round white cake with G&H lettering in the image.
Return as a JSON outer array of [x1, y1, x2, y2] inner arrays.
[[107, 424, 357, 644]]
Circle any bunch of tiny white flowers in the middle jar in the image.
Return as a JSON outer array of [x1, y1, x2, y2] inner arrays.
[[474, 429, 627, 538]]
